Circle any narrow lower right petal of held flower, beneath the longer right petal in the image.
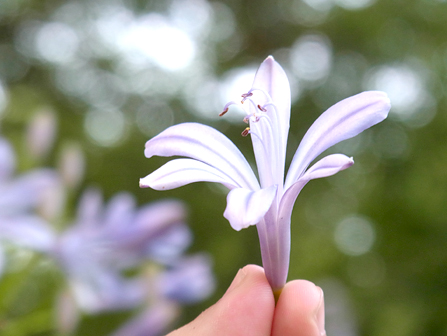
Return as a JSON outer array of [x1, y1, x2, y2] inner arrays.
[[279, 154, 354, 224]]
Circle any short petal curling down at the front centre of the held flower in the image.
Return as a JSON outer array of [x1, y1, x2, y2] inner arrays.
[[224, 185, 277, 231]]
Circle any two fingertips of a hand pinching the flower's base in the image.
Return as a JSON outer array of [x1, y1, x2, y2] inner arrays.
[[168, 265, 326, 336]]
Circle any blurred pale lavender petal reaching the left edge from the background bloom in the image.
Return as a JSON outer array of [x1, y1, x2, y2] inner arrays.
[[0, 216, 56, 252]]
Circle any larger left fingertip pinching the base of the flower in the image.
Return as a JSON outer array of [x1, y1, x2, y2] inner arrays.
[[169, 265, 275, 336]]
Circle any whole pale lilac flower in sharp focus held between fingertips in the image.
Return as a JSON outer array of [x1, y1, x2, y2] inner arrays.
[[140, 56, 390, 292]]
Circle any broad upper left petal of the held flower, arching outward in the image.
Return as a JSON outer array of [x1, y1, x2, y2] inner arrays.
[[144, 123, 259, 189]]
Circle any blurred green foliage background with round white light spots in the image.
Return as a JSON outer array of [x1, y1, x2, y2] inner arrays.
[[0, 0, 447, 336]]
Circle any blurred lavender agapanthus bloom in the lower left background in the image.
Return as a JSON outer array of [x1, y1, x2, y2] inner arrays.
[[0, 189, 214, 335]]
